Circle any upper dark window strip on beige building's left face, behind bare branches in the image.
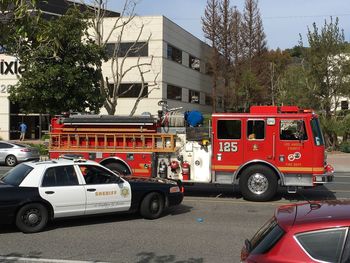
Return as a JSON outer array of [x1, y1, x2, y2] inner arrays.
[[106, 42, 148, 58]]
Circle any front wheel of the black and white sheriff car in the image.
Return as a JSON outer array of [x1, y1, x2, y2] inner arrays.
[[140, 192, 164, 219]]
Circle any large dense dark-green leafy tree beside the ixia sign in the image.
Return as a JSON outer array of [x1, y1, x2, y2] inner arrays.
[[10, 9, 104, 114]]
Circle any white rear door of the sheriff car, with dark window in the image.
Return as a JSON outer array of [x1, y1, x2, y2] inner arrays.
[[39, 165, 85, 218]]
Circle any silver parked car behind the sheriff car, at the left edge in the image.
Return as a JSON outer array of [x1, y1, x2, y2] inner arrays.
[[0, 141, 40, 166]]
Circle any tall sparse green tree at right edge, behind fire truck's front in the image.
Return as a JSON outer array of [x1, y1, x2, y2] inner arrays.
[[301, 18, 350, 149]]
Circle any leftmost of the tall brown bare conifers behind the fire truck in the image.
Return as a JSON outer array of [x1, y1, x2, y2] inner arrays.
[[202, 0, 220, 112]]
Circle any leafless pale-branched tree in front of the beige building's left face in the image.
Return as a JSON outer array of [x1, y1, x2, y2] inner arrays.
[[83, 0, 159, 116]]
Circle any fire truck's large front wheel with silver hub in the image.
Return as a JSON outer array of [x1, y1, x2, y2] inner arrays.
[[239, 165, 278, 202]]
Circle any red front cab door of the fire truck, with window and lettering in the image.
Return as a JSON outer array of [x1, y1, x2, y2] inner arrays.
[[276, 118, 313, 177]]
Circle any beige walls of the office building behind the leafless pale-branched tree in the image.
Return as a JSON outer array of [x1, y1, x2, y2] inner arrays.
[[99, 16, 219, 115]]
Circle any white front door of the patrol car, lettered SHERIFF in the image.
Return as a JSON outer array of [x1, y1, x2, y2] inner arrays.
[[79, 164, 131, 217]]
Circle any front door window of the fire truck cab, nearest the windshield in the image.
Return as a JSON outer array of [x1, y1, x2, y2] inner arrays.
[[280, 120, 307, 141]]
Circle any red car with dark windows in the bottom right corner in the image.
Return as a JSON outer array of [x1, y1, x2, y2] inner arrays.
[[241, 200, 350, 263]]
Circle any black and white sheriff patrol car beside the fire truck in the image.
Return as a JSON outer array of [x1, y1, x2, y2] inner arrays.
[[0, 159, 183, 233]]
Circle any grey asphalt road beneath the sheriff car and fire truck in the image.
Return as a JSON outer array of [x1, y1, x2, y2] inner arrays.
[[0, 170, 350, 263]]
